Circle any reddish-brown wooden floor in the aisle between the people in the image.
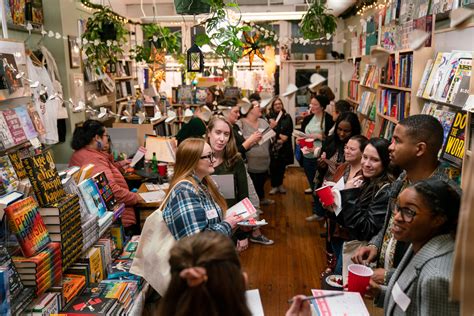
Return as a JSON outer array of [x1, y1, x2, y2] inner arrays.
[[241, 168, 326, 315]]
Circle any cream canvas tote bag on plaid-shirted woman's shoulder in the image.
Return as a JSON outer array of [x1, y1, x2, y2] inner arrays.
[[130, 180, 190, 296]]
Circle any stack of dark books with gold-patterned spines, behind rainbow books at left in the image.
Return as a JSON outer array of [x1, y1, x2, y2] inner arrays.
[[39, 194, 83, 270]]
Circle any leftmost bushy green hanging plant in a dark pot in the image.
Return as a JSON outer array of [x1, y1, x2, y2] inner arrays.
[[82, 8, 128, 73]]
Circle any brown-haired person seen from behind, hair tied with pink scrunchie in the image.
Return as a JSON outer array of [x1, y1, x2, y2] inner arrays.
[[157, 232, 311, 316]]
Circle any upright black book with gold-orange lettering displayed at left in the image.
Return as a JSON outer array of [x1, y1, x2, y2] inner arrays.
[[22, 150, 66, 206]]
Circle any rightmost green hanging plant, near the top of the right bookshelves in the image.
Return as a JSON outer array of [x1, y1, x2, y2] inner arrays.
[[300, 0, 337, 40]]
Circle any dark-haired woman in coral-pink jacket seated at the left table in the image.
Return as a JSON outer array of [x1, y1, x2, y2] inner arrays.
[[69, 120, 143, 235]]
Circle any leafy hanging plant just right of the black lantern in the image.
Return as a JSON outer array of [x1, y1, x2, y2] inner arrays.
[[195, 0, 251, 69]]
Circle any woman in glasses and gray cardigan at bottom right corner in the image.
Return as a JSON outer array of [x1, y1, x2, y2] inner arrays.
[[370, 178, 460, 316]]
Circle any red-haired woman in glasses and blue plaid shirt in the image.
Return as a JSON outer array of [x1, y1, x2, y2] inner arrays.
[[163, 138, 241, 239]]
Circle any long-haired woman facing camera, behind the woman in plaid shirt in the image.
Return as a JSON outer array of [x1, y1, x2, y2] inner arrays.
[[207, 116, 273, 250]]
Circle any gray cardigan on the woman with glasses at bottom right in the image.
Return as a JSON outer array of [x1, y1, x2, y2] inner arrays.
[[376, 234, 459, 316]]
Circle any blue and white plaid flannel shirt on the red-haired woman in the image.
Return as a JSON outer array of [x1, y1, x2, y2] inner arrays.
[[163, 178, 232, 240]]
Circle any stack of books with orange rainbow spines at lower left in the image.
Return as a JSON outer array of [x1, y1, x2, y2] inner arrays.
[[13, 242, 63, 295]]
